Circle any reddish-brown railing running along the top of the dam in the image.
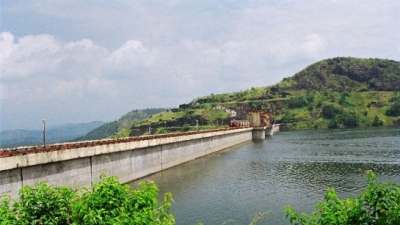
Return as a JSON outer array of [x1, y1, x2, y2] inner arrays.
[[0, 127, 245, 158]]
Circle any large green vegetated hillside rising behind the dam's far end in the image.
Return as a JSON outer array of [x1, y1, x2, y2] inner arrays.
[[101, 57, 400, 137]]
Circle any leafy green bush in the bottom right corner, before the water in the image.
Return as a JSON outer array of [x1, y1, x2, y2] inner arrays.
[[285, 171, 400, 225]]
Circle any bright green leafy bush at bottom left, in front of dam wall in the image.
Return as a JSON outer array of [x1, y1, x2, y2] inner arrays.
[[0, 177, 175, 225]]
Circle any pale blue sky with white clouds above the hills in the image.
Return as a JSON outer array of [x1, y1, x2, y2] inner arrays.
[[0, 0, 400, 130]]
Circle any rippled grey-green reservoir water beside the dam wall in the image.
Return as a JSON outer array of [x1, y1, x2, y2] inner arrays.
[[130, 127, 400, 225]]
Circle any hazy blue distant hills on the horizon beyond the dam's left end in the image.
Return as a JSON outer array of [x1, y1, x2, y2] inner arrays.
[[0, 121, 103, 148]]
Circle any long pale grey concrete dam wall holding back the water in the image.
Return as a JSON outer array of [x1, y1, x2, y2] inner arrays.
[[0, 128, 252, 198]]
